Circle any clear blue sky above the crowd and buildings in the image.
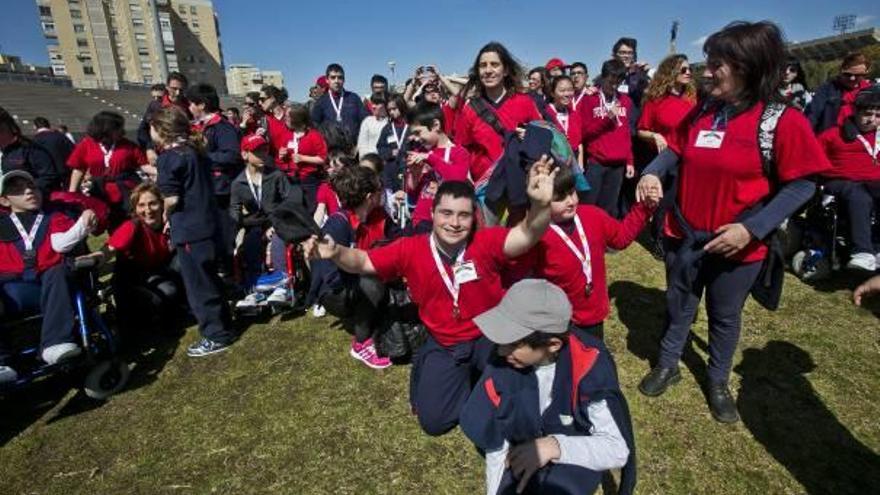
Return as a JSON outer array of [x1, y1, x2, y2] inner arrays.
[[0, 0, 880, 99]]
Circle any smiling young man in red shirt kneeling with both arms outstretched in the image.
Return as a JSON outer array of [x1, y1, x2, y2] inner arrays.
[[304, 157, 556, 435]]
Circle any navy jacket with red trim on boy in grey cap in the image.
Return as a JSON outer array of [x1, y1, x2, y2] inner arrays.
[[459, 329, 636, 494]]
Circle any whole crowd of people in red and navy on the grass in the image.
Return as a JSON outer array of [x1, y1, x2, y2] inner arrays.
[[0, 17, 880, 494]]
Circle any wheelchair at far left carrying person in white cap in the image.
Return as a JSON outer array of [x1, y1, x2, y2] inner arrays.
[[0, 257, 130, 400]]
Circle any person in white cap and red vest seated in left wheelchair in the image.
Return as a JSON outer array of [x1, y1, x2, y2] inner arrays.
[[0, 170, 98, 382]]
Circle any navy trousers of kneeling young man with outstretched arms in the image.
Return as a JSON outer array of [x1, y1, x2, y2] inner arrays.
[[410, 335, 495, 436]]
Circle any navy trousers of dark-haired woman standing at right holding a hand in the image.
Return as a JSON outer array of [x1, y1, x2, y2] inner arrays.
[[658, 242, 761, 384]]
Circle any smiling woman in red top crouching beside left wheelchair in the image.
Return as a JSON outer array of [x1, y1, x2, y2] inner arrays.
[[107, 183, 183, 328]]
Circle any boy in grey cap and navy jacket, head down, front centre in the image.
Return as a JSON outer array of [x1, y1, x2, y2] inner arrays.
[[460, 279, 635, 495]]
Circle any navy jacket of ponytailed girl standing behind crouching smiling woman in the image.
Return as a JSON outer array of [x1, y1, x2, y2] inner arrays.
[[156, 145, 218, 245]]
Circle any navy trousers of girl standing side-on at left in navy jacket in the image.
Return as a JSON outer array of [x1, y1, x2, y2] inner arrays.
[[177, 239, 235, 344]]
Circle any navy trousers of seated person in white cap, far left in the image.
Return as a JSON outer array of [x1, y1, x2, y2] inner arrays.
[[0, 263, 76, 364]]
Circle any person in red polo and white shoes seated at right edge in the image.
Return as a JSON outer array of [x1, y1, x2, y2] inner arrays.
[[819, 85, 880, 271]]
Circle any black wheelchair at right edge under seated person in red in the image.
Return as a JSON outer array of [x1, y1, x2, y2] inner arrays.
[[782, 189, 880, 281]]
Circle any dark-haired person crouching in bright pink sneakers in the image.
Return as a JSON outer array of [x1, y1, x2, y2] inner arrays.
[[309, 167, 400, 369]]
